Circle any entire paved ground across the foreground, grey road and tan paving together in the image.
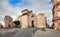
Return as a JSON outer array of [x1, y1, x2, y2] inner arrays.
[[0, 28, 60, 37]]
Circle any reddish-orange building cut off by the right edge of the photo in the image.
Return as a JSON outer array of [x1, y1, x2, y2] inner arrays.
[[52, 0, 60, 29]]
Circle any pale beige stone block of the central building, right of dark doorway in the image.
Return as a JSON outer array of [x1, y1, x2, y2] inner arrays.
[[37, 13, 46, 28]]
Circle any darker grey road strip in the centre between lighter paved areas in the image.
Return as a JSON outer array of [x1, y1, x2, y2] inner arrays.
[[14, 28, 36, 37]]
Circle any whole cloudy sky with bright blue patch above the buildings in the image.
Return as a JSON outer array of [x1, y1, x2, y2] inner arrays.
[[0, 0, 52, 24]]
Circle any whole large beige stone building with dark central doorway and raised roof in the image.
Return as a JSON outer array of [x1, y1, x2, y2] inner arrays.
[[16, 9, 46, 28]]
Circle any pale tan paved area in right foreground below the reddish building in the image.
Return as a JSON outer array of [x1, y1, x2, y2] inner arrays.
[[33, 29, 60, 37]]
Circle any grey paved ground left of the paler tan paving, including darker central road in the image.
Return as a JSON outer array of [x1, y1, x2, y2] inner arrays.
[[0, 28, 36, 37]]
